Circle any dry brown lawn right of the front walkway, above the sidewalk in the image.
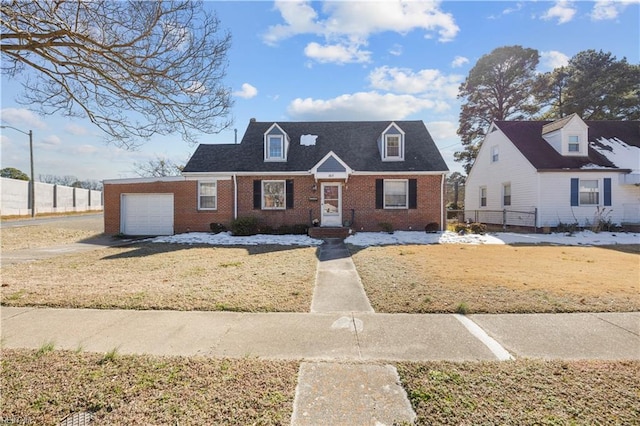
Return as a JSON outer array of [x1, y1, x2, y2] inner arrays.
[[351, 245, 640, 313]]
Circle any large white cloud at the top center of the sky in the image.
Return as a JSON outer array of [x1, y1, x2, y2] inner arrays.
[[263, 0, 460, 63]]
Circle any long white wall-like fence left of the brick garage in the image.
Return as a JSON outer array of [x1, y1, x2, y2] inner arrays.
[[0, 178, 104, 216]]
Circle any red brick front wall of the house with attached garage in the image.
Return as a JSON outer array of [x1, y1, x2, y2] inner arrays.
[[104, 175, 442, 235]]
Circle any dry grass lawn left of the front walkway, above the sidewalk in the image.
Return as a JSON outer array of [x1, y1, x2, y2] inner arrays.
[[2, 243, 317, 312]]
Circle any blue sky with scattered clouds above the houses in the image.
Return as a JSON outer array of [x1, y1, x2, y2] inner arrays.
[[0, 0, 640, 180]]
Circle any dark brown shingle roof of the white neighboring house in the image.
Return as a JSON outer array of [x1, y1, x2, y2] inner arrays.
[[495, 120, 640, 170]]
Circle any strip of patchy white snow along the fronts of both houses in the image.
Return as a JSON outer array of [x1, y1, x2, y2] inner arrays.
[[152, 231, 640, 247]]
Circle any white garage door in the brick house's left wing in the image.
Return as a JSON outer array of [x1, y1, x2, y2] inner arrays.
[[120, 194, 173, 235]]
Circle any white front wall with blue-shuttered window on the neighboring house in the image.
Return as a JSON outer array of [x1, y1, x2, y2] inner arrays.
[[538, 172, 640, 227]]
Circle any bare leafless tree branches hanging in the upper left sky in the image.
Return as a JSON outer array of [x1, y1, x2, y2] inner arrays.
[[0, 0, 232, 148]]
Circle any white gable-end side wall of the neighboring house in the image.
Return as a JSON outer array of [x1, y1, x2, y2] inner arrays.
[[464, 130, 537, 223]]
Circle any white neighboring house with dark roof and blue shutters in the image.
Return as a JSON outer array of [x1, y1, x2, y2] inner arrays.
[[465, 114, 640, 228]]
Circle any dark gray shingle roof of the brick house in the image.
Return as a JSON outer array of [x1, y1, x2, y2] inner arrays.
[[184, 121, 448, 172]]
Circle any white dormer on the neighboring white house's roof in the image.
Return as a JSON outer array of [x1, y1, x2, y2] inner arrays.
[[542, 114, 589, 157]]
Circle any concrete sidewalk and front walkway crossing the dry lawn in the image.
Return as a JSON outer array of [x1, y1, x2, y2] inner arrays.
[[0, 241, 640, 426]]
